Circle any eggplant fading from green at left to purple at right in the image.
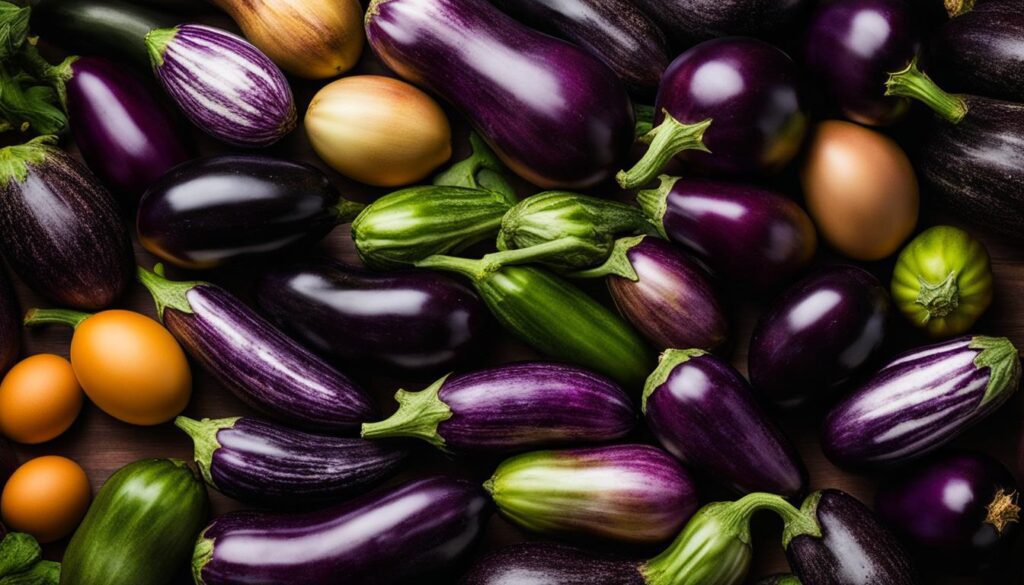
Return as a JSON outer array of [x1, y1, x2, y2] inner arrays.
[[483, 445, 697, 544]]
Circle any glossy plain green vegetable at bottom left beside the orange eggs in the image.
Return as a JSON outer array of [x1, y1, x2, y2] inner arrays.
[[60, 459, 209, 585]]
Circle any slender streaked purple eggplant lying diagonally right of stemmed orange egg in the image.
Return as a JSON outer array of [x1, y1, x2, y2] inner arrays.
[[138, 267, 376, 432]]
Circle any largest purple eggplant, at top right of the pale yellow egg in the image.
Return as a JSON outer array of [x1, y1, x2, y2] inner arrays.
[[367, 0, 634, 189]]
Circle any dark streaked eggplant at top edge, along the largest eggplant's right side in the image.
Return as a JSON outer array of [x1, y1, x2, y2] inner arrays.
[[495, 0, 670, 92]]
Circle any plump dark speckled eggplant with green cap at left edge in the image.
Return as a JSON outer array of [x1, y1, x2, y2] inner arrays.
[[0, 137, 132, 310]]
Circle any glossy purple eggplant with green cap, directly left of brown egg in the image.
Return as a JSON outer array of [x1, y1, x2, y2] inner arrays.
[[637, 176, 817, 291]]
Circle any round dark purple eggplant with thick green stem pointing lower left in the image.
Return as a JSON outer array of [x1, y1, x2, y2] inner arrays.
[[616, 37, 807, 189]]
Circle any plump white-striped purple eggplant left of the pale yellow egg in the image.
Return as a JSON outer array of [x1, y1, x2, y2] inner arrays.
[[145, 25, 296, 147]]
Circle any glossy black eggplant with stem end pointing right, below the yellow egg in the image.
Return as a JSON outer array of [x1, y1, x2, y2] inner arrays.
[[136, 155, 362, 269]]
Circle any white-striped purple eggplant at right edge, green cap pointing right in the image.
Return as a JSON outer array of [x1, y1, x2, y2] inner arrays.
[[821, 335, 1021, 468]]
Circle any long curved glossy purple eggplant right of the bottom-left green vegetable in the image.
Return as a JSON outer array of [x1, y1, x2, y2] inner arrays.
[[193, 476, 489, 585]]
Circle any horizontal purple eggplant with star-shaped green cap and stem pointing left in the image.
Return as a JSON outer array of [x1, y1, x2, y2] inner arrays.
[[362, 362, 637, 453]]
